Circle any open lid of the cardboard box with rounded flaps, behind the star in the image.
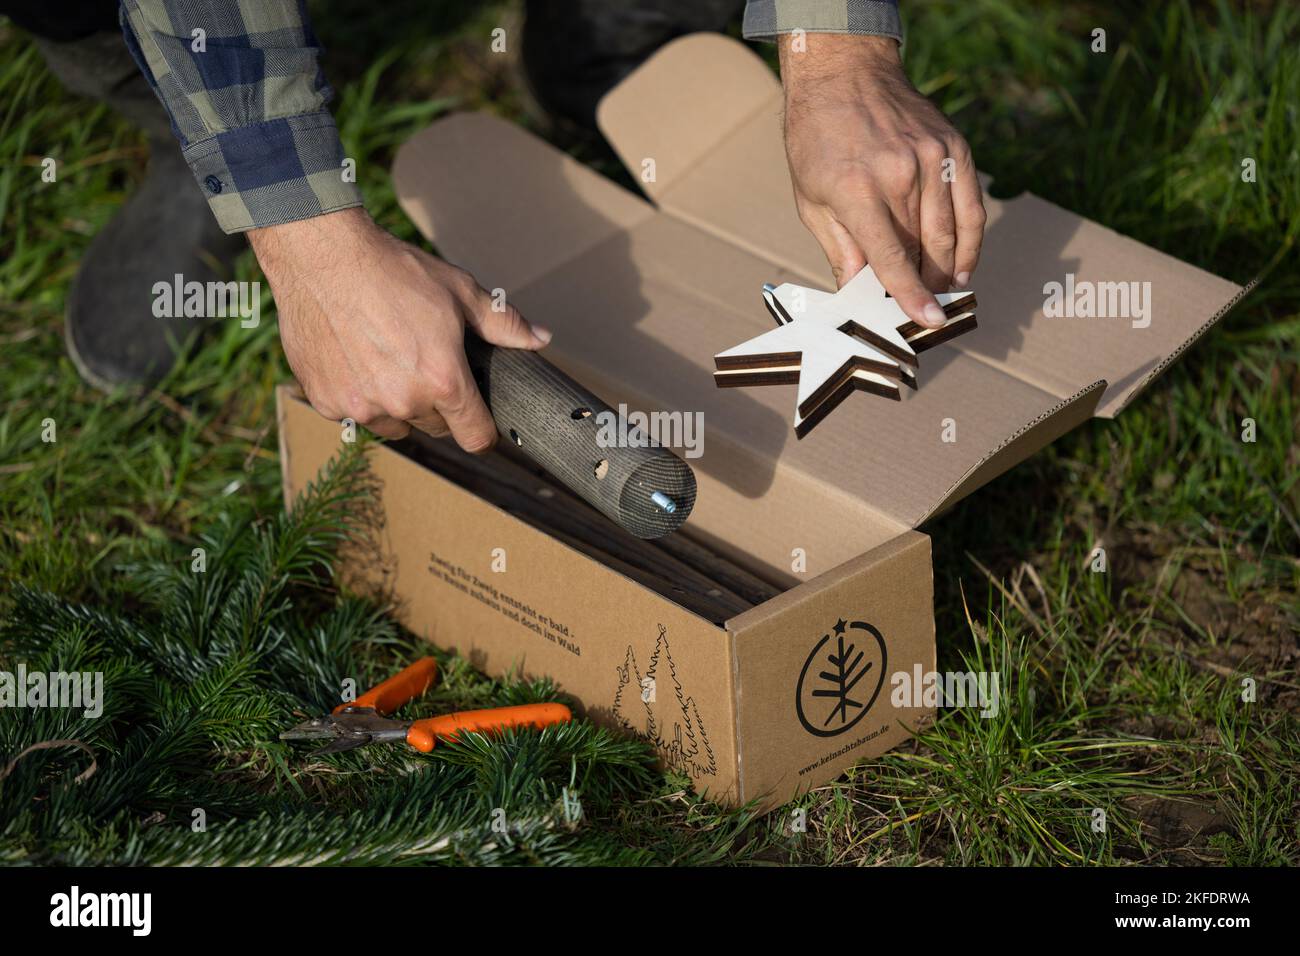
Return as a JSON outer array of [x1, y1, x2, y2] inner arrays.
[[394, 34, 1243, 579]]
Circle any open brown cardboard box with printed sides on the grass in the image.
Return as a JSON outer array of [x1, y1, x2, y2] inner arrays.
[[280, 35, 1244, 806]]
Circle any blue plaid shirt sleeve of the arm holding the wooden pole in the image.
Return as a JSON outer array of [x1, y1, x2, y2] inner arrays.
[[120, 0, 361, 233]]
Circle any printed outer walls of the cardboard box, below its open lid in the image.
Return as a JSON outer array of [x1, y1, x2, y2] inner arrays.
[[277, 386, 935, 806]]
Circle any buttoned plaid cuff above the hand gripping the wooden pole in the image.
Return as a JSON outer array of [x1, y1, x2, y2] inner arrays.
[[183, 112, 363, 233]]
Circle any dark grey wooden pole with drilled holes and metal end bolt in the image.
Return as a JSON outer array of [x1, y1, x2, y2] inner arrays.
[[465, 333, 696, 538]]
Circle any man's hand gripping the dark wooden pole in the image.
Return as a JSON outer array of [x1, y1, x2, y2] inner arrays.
[[248, 208, 551, 453]]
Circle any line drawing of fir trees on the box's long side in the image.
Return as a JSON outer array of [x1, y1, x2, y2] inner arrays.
[[614, 624, 718, 777]]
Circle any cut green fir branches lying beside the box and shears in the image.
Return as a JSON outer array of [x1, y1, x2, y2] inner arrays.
[[0, 446, 696, 865]]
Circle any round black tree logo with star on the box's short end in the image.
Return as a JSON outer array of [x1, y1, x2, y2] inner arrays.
[[794, 618, 887, 737]]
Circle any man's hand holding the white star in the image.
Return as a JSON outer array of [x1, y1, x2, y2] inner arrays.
[[780, 34, 985, 328]]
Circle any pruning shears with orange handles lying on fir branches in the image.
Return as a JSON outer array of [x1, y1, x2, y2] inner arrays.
[[280, 657, 573, 757]]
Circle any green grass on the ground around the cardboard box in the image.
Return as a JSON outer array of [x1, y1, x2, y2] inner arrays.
[[0, 0, 1300, 865]]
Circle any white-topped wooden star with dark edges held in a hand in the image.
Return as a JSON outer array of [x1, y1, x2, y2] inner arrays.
[[714, 267, 975, 438]]
